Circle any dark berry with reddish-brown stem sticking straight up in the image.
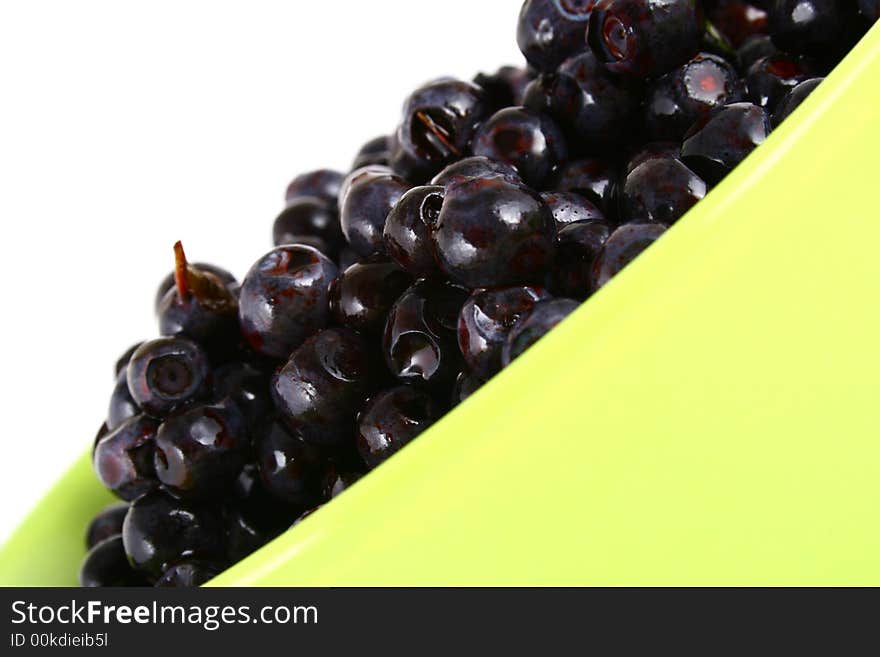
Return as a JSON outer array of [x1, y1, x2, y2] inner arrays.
[[159, 242, 239, 355]]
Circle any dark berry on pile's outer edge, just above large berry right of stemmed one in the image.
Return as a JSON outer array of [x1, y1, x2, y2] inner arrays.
[[272, 196, 345, 258]]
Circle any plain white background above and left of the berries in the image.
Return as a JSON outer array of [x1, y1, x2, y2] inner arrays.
[[0, 0, 521, 542]]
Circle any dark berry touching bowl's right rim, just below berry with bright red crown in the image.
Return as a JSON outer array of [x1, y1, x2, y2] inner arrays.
[[620, 158, 707, 225]]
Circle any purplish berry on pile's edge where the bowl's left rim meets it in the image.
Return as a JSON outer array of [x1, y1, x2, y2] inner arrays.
[[92, 415, 159, 501]]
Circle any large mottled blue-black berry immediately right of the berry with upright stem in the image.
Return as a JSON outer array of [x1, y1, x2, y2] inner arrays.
[[238, 245, 339, 358]]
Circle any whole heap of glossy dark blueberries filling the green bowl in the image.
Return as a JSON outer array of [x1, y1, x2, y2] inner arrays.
[[80, 0, 880, 586]]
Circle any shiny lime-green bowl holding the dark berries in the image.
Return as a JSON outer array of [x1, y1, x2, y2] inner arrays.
[[0, 27, 880, 586]]
